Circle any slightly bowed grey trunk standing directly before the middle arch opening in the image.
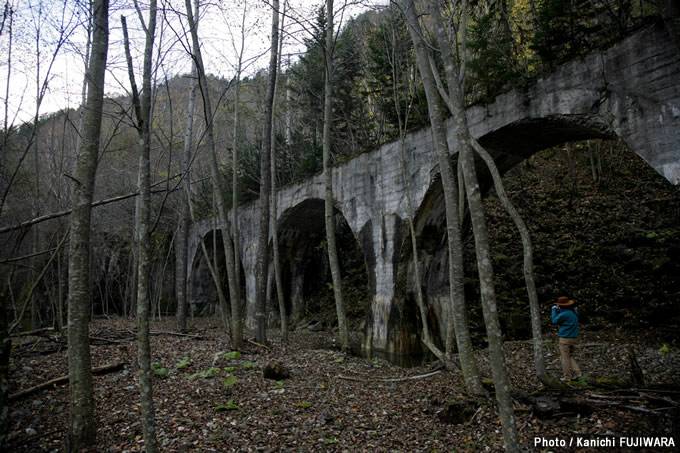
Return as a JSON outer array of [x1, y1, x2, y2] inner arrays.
[[323, 0, 349, 351]]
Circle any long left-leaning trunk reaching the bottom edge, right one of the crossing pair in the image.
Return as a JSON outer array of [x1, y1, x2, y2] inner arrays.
[[429, 2, 520, 452]]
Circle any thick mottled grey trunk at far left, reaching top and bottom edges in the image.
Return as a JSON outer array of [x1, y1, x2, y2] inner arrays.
[[66, 0, 109, 452]]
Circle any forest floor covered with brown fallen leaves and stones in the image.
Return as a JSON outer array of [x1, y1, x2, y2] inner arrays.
[[9, 318, 680, 452]]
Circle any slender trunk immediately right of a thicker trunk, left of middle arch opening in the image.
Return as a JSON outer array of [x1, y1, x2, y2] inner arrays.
[[271, 0, 288, 343]]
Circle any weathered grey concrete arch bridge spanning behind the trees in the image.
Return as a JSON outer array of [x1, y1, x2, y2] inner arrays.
[[189, 26, 680, 353]]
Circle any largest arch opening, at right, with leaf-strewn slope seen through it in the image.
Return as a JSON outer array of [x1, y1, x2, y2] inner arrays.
[[405, 134, 680, 345]]
